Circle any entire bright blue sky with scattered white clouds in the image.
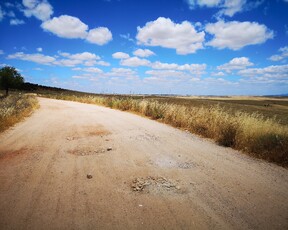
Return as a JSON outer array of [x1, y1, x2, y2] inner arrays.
[[0, 0, 288, 95]]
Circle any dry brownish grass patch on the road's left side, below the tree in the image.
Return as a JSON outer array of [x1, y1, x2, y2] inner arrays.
[[0, 95, 39, 132]]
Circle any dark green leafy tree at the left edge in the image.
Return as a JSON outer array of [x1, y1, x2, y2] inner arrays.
[[0, 66, 24, 97]]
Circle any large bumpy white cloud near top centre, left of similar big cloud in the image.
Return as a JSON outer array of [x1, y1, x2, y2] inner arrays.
[[136, 17, 205, 55]]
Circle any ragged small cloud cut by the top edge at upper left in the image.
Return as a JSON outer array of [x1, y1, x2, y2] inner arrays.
[[22, 0, 53, 21]]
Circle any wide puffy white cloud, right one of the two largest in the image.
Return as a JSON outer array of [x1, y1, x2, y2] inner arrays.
[[205, 21, 274, 50]]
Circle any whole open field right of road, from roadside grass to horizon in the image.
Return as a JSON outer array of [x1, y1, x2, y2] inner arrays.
[[35, 92, 288, 166]]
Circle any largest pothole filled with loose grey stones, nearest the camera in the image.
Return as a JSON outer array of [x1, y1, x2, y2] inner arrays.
[[131, 176, 181, 192]]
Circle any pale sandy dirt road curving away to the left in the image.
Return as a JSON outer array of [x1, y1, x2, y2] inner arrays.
[[0, 98, 288, 230]]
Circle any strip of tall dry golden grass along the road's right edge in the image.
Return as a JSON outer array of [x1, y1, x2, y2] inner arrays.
[[42, 94, 288, 166]]
